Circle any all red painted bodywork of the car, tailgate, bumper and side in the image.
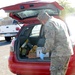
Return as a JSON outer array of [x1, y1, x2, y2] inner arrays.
[[1, 2, 75, 75]]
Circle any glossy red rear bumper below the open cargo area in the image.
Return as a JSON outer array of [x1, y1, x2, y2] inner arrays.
[[8, 57, 50, 75]]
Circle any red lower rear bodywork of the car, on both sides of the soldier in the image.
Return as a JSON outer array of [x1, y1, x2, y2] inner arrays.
[[8, 46, 75, 75]]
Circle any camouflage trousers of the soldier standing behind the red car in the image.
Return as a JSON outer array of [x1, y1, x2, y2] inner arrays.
[[50, 56, 70, 75]]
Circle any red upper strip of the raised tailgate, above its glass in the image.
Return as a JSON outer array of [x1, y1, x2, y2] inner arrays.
[[0, 1, 63, 12]]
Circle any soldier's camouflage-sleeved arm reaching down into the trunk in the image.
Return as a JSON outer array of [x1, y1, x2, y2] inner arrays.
[[42, 22, 55, 53]]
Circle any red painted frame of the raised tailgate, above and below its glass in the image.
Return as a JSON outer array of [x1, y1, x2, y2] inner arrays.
[[0, 1, 64, 24]]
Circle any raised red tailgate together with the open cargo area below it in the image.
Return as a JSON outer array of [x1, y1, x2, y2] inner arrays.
[[1, 1, 63, 61]]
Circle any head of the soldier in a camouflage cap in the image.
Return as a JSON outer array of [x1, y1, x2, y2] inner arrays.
[[37, 11, 50, 24]]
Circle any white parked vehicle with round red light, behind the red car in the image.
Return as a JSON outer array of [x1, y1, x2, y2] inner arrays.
[[0, 20, 22, 42]]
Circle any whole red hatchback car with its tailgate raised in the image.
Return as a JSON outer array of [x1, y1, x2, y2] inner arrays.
[[2, 1, 75, 75]]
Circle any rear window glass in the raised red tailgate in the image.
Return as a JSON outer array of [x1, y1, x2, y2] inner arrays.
[[16, 9, 58, 19]]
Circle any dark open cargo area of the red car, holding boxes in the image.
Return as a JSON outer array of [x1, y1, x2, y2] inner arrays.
[[15, 24, 50, 61]]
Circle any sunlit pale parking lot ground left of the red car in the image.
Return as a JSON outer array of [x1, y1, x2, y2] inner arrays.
[[0, 37, 15, 75]]
